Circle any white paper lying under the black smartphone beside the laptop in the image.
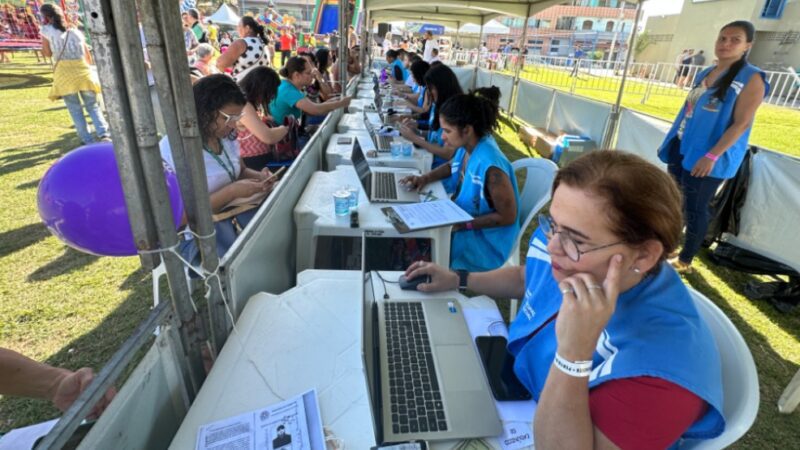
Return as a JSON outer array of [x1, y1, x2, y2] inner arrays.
[[463, 308, 536, 450]]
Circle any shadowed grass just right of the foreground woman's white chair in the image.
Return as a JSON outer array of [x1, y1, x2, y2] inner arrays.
[[687, 268, 800, 449]]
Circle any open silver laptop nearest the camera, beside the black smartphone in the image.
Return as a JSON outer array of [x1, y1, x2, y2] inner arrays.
[[362, 266, 503, 443]]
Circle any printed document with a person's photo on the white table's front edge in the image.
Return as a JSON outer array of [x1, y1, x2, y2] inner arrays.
[[196, 389, 325, 450]]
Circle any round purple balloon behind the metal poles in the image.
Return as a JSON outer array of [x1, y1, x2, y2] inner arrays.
[[37, 142, 183, 256]]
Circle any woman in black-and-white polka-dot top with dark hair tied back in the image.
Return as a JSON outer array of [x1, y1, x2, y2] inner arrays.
[[217, 16, 270, 81]]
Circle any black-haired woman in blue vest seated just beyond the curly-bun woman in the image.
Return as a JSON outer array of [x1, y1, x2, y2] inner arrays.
[[400, 64, 464, 170]]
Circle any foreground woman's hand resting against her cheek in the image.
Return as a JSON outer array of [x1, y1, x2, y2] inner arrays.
[[556, 255, 622, 361]]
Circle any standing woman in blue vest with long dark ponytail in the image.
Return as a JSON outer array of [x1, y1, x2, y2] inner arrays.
[[658, 20, 769, 272]]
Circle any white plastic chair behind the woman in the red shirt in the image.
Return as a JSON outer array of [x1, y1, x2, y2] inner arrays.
[[681, 288, 759, 449]]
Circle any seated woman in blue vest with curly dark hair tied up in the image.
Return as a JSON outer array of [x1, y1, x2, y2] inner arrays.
[[404, 86, 519, 272]]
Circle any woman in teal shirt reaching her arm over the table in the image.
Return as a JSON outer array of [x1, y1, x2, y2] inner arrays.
[[269, 56, 350, 124]]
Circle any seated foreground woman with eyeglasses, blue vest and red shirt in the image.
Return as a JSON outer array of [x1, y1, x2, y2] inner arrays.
[[406, 151, 725, 449]]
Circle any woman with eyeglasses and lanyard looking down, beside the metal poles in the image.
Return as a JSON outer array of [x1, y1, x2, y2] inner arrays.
[[159, 74, 277, 262]]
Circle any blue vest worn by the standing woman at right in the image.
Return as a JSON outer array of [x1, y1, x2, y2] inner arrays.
[[658, 63, 769, 179]]
